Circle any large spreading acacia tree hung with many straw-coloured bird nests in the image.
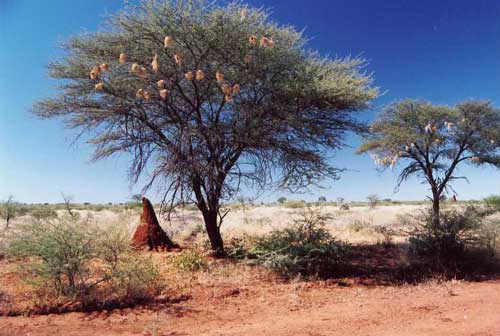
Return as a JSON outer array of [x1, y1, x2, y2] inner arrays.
[[34, 0, 378, 254]]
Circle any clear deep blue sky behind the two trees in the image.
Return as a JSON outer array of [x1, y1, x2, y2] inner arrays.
[[0, 0, 500, 202]]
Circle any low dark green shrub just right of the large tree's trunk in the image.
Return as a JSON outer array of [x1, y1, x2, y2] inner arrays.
[[249, 209, 347, 277]]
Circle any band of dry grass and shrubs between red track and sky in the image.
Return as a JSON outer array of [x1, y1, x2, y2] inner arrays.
[[0, 196, 500, 314]]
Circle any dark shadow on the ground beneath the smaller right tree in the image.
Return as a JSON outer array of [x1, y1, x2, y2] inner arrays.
[[329, 244, 500, 286]]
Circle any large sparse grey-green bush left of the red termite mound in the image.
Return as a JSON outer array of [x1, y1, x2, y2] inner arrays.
[[7, 217, 162, 306]]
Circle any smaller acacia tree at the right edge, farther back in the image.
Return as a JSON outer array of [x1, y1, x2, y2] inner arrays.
[[358, 100, 500, 228]]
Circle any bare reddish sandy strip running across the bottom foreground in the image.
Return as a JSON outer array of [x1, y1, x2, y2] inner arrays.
[[0, 274, 500, 336]]
